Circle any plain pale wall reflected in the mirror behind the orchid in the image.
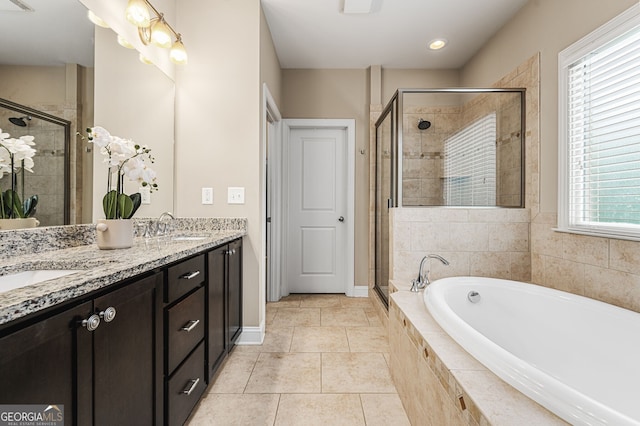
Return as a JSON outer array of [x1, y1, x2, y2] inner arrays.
[[90, 27, 175, 222]]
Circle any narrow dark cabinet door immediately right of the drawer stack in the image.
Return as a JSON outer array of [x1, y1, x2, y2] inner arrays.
[[207, 245, 227, 380]]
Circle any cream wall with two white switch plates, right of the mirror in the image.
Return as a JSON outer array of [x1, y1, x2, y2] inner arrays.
[[175, 0, 265, 327]]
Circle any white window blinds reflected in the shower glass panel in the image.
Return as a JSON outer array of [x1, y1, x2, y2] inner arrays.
[[444, 113, 496, 206]]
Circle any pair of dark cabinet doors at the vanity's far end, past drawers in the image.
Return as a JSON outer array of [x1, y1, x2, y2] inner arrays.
[[207, 239, 242, 382]]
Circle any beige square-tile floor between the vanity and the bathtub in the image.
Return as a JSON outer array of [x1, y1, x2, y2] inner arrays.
[[188, 294, 409, 426]]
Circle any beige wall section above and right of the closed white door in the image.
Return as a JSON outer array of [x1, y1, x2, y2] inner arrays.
[[280, 69, 369, 286]]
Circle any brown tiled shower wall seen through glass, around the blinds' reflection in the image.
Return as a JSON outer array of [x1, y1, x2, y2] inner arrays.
[[402, 93, 521, 207]]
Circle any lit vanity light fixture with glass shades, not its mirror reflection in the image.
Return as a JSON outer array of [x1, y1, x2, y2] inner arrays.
[[125, 0, 187, 64]]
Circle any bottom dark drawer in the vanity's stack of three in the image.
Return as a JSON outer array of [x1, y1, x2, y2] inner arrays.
[[167, 343, 206, 425]]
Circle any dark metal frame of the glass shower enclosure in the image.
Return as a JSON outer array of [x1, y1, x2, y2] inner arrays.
[[374, 88, 526, 307]]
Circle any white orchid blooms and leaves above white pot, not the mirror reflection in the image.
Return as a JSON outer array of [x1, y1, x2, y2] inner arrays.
[[87, 126, 158, 219]]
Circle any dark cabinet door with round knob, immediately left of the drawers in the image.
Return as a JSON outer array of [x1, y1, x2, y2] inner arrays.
[[93, 273, 162, 425]]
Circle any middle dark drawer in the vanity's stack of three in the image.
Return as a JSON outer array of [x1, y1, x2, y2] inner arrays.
[[167, 287, 205, 374]]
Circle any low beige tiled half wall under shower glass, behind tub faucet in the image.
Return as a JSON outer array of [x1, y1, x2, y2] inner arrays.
[[390, 207, 531, 283]]
